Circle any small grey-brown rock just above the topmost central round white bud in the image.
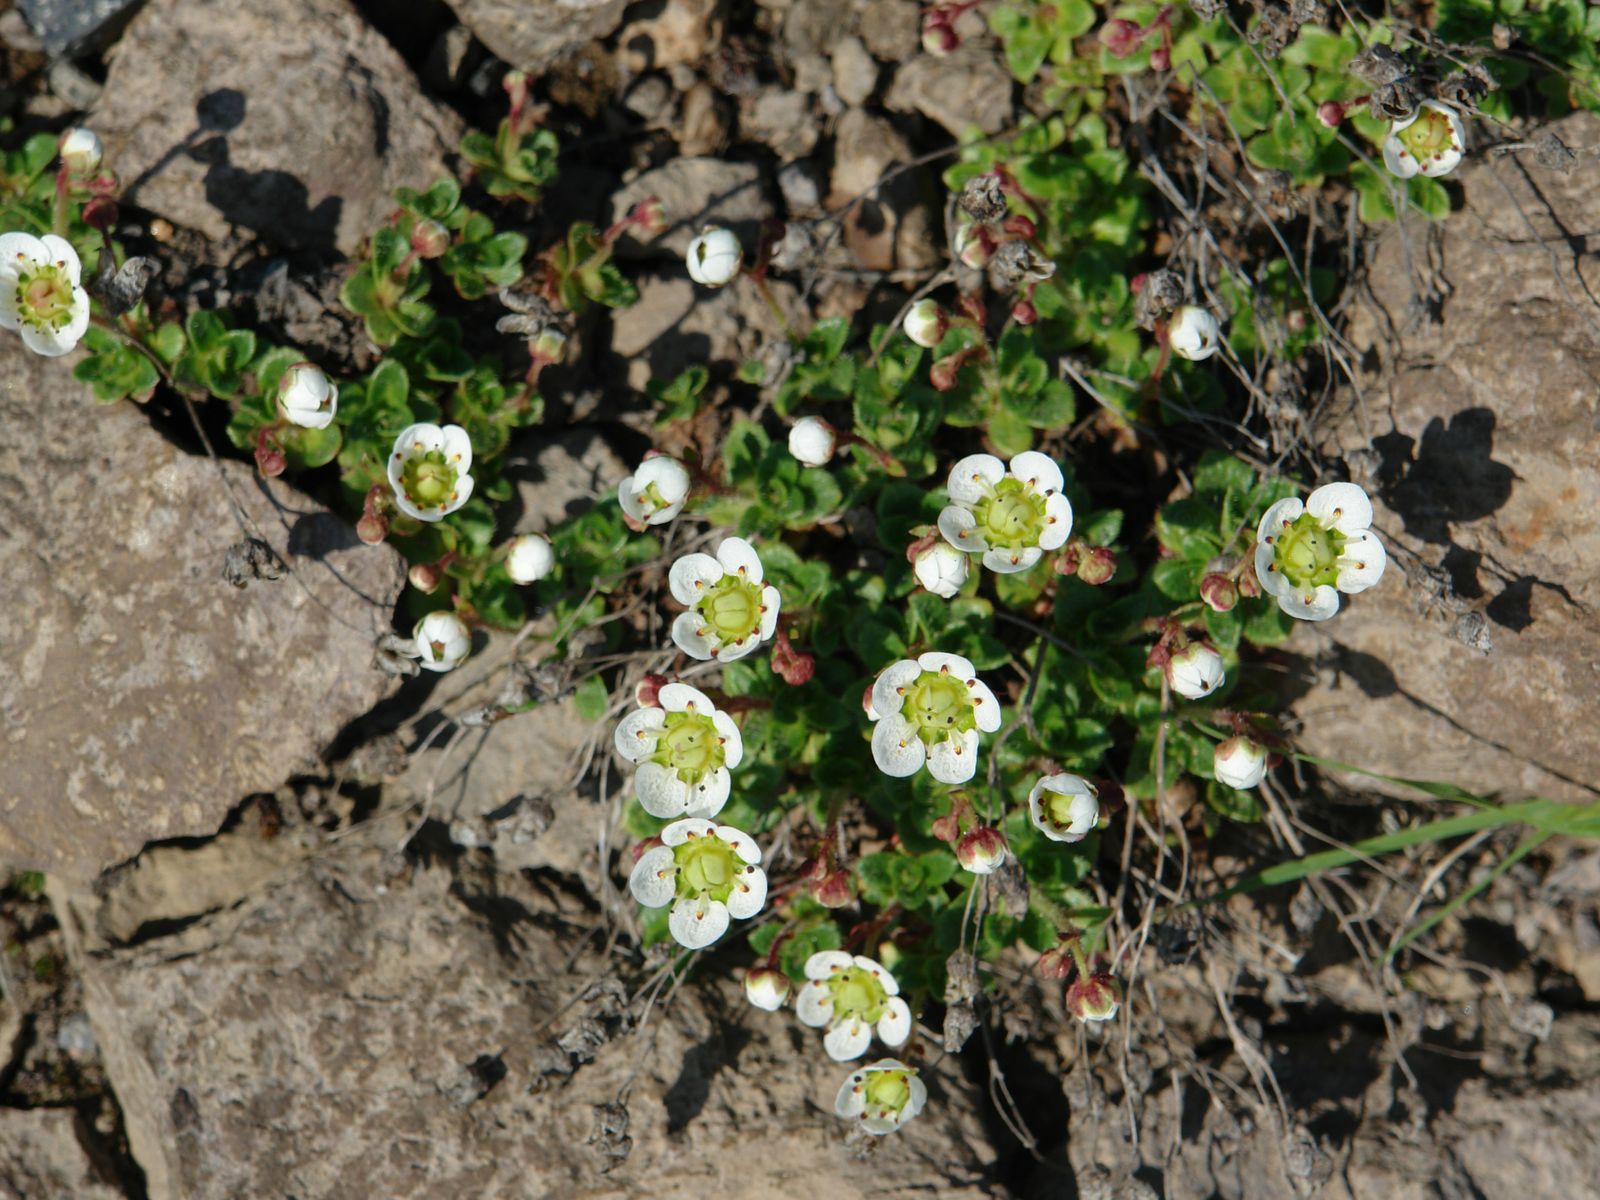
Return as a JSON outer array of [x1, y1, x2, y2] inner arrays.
[[611, 158, 773, 264]]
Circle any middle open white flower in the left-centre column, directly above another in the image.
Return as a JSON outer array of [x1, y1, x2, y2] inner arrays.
[[614, 683, 744, 818]]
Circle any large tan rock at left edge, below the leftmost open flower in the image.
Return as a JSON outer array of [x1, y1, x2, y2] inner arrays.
[[0, 342, 403, 878]]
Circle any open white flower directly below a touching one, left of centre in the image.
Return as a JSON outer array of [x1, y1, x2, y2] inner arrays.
[[627, 818, 766, 950]]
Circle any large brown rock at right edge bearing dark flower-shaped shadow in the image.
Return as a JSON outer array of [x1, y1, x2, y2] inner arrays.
[[1290, 115, 1600, 800]]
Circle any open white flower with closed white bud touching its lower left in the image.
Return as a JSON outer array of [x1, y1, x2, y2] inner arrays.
[[939, 450, 1072, 574]]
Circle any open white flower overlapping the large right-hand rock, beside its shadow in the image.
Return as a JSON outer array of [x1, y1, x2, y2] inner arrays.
[[1256, 483, 1389, 621]]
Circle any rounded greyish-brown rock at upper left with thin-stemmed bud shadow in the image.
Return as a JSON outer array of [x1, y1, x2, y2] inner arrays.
[[90, 0, 461, 254]]
